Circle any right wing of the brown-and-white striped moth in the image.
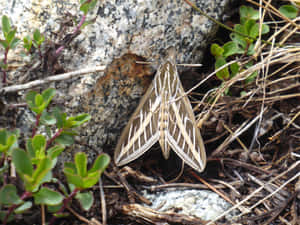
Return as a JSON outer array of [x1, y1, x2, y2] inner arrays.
[[167, 64, 206, 172]]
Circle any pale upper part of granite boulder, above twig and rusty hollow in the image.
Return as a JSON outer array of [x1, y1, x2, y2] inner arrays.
[[0, 0, 229, 78]]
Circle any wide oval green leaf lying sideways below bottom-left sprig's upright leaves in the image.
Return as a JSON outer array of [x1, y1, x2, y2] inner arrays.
[[33, 187, 64, 206]]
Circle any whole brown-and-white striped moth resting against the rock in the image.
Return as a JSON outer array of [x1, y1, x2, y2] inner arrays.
[[114, 47, 206, 172]]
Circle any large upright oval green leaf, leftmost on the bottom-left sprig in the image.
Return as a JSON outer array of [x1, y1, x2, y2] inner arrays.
[[12, 148, 33, 177]]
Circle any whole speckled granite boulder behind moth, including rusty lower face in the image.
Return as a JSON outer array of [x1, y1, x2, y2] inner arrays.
[[0, 0, 230, 160]]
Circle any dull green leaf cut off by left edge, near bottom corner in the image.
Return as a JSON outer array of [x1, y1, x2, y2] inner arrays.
[[0, 184, 23, 205]]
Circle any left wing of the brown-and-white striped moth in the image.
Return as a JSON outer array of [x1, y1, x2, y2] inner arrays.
[[114, 83, 161, 166]]
